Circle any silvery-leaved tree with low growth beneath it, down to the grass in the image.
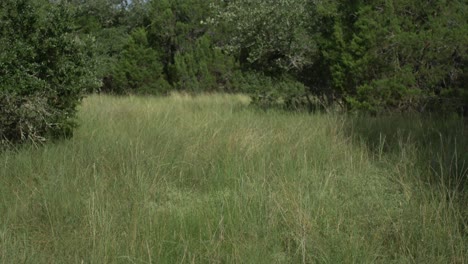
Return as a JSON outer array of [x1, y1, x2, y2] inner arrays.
[[210, 0, 318, 108]]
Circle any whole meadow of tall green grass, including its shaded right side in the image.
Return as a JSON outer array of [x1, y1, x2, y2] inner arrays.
[[0, 95, 468, 264]]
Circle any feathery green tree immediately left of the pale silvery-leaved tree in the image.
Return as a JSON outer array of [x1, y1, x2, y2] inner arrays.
[[148, 0, 241, 92]]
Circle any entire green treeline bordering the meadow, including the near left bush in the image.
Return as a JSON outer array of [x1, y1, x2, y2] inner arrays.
[[0, 0, 468, 144]]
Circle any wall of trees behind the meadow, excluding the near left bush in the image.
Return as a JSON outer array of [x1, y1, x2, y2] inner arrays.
[[62, 0, 468, 113]]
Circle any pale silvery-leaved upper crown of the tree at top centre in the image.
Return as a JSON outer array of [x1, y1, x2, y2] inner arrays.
[[213, 0, 316, 75]]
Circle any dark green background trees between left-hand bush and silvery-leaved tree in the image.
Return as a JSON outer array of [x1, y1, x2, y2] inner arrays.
[[71, 0, 238, 95]]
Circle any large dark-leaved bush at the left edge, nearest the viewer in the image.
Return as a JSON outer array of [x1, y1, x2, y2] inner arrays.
[[0, 0, 98, 145]]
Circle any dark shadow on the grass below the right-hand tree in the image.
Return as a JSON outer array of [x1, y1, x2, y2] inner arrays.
[[345, 112, 468, 197]]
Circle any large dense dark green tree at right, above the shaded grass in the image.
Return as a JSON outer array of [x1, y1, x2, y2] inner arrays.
[[314, 0, 468, 112]]
